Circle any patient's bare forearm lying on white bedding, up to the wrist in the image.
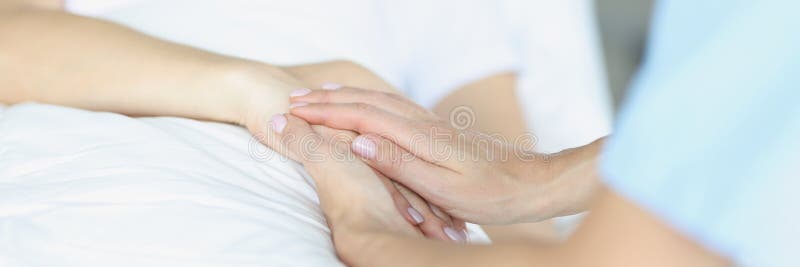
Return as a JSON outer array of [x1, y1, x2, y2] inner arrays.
[[0, 8, 299, 122]]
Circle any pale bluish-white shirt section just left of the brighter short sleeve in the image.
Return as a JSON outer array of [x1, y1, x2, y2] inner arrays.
[[405, 0, 517, 107]]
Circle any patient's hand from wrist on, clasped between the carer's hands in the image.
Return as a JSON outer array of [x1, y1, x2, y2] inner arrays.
[[216, 61, 466, 242]]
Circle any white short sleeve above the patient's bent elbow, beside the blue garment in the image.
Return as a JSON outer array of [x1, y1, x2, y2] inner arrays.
[[500, 0, 612, 152]]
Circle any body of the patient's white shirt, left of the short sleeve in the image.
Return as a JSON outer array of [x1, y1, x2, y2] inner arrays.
[[66, 0, 516, 106]]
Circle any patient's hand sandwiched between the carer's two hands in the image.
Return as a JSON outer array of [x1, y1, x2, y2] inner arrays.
[[222, 62, 466, 242]]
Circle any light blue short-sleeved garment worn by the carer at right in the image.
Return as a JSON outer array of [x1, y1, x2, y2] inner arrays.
[[602, 0, 800, 266]]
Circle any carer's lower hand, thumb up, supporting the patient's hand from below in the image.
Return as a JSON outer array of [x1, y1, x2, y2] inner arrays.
[[271, 115, 422, 262]]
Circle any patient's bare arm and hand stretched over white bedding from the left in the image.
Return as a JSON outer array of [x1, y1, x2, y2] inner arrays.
[[0, 0, 464, 241]]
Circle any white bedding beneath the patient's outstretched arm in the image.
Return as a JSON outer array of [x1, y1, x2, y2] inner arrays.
[[0, 104, 486, 266]]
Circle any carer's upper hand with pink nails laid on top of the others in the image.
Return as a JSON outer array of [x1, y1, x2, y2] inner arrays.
[[290, 88, 596, 224]]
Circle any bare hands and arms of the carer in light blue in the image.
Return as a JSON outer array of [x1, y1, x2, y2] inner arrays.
[[272, 88, 730, 266]]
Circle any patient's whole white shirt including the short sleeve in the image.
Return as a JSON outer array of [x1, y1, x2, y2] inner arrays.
[[66, 0, 611, 151]]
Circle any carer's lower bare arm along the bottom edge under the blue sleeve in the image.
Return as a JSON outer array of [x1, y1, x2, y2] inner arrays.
[[341, 188, 729, 267]]
